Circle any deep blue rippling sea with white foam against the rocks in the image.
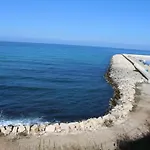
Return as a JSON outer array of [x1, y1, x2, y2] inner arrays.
[[0, 42, 150, 124]]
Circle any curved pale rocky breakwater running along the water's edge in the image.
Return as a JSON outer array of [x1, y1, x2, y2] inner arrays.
[[0, 55, 147, 136]]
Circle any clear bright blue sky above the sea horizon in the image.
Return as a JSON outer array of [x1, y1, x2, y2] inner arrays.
[[0, 0, 150, 47]]
